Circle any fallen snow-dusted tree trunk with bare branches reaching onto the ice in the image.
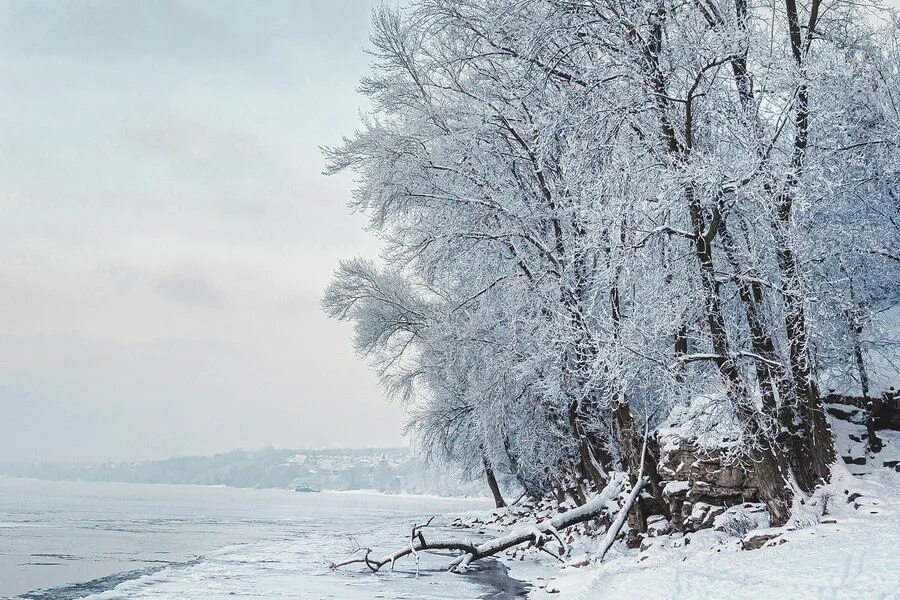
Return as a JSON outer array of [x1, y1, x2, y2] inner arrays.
[[331, 474, 624, 573]]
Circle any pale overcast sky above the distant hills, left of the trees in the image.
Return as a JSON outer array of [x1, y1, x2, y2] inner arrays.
[[0, 0, 403, 461]]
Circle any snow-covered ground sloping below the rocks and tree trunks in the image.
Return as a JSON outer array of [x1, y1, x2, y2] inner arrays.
[[510, 468, 900, 600]]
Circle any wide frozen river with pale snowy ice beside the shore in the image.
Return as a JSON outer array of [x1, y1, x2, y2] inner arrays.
[[0, 478, 521, 600]]
